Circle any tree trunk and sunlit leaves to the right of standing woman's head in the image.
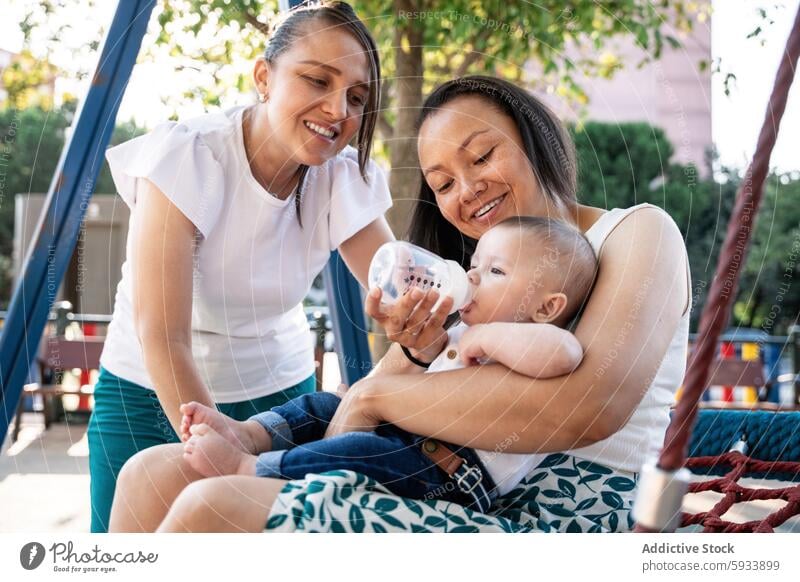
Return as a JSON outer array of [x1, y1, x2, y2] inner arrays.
[[364, 0, 704, 232]]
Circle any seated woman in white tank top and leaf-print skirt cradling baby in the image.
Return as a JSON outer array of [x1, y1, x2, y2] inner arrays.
[[101, 2, 690, 531]]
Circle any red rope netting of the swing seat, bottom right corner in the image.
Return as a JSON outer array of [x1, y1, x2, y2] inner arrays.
[[681, 451, 800, 533]]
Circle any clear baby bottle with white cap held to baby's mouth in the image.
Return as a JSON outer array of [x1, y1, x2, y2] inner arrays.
[[369, 241, 472, 313]]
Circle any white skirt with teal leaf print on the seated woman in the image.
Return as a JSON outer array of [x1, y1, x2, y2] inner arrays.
[[266, 454, 638, 533]]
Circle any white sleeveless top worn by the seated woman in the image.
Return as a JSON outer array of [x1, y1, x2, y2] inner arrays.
[[566, 204, 691, 472]]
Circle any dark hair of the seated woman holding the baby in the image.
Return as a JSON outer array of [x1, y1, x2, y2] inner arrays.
[[408, 75, 577, 269]]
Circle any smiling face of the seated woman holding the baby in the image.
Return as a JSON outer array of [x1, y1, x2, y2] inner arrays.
[[417, 96, 548, 239]]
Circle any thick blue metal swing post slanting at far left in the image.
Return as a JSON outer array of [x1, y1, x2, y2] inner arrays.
[[0, 0, 155, 443]]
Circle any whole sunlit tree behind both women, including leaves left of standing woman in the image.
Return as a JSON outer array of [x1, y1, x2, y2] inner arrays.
[[17, 0, 710, 233]]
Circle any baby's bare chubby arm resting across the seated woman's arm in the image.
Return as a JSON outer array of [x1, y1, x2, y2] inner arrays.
[[458, 322, 583, 378]]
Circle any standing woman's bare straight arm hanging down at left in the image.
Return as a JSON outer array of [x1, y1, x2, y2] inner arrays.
[[131, 180, 214, 434]]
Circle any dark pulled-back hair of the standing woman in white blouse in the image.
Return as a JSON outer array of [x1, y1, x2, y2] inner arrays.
[[264, 1, 381, 224]]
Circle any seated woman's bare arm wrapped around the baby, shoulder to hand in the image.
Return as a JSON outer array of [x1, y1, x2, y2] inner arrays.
[[329, 209, 688, 453]]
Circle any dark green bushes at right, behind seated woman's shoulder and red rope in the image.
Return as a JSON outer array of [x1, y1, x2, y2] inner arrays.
[[573, 123, 800, 334]]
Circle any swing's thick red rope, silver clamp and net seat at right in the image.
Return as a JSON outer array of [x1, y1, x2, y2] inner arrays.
[[634, 2, 800, 532]]
